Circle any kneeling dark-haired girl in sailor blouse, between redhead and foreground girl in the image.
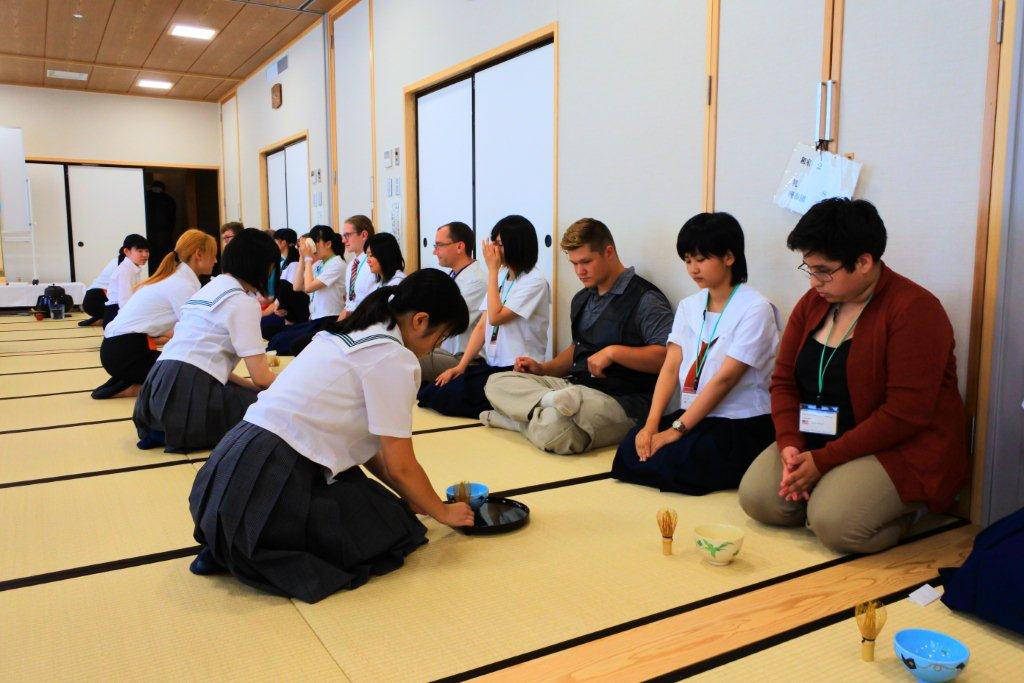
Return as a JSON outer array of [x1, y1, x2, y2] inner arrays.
[[133, 228, 279, 453]]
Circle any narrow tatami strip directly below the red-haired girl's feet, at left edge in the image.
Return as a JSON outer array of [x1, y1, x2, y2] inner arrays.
[[0, 393, 135, 432]]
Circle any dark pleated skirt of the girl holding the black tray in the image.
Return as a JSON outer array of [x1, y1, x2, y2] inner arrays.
[[188, 422, 427, 602]]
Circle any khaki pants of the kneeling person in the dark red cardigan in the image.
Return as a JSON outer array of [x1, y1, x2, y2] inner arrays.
[[739, 443, 925, 553]]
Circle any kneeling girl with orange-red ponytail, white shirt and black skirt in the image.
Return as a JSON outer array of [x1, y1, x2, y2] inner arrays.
[[92, 229, 217, 398]]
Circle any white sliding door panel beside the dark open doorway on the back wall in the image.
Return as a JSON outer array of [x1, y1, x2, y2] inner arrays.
[[68, 166, 145, 283]]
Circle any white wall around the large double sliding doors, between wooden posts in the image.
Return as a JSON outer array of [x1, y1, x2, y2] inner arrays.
[[374, 0, 707, 345]]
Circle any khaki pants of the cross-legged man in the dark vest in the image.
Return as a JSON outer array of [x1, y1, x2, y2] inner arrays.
[[483, 373, 634, 455]]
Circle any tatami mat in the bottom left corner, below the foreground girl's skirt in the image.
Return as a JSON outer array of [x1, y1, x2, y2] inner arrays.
[[0, 558, 347, 681]]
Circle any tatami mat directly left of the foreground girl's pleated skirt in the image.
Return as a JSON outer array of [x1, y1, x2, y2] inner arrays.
[[0, 466, 196, 581]]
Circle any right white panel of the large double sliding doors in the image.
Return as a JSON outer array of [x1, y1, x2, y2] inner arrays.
[[474, 45, 555, 353]]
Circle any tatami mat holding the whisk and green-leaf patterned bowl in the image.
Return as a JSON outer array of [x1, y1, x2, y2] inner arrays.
[[296, 480, 837, 681]]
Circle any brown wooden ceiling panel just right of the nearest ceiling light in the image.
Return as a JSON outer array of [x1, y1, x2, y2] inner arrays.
[[191, 5, 295, 76]]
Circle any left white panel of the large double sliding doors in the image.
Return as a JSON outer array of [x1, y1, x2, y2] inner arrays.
[[416, 78, 473, 268]]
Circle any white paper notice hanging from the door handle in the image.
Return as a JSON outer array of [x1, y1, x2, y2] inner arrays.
[[774, 143, 863, 214]]
